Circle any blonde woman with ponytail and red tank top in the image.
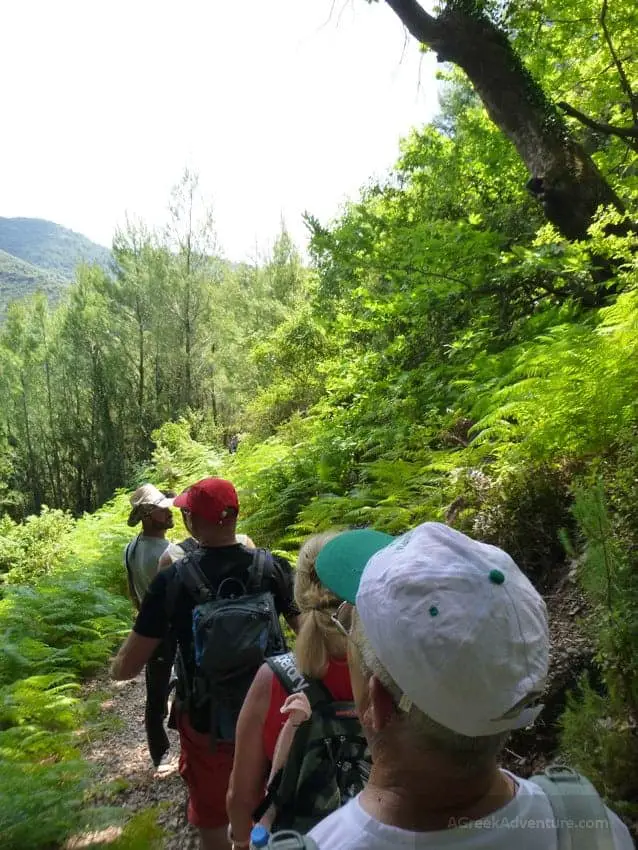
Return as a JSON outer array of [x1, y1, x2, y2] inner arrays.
[[227, 533, 366, 848]]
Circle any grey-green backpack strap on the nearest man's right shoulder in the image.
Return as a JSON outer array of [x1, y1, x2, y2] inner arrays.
[[531, 765, 614, 850]]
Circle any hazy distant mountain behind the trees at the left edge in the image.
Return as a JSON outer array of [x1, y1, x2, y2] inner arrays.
[[0, 217, 111, 317]]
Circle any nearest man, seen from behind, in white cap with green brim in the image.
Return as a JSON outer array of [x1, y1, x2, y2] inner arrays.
[[310, 523, 633, 850]]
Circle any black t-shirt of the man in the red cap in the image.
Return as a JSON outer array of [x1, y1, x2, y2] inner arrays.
[[133, 543, 299, 724]]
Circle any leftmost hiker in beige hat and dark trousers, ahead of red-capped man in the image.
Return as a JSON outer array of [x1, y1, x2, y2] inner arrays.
[[124, 484, 175, 772]]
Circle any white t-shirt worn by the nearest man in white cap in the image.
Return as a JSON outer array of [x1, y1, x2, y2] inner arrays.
[[310, 774, 634, 850]]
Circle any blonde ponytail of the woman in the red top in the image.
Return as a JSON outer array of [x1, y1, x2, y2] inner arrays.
[[295, 531, 346, 679]]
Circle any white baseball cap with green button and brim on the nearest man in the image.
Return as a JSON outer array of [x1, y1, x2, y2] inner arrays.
[[317, 522, 549, 738]]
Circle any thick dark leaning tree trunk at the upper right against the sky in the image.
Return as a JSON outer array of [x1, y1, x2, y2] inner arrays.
[[386, 0, 623, 239]]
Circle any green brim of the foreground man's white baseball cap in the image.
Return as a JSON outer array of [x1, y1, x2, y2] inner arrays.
[[315, 528, 394, 605]]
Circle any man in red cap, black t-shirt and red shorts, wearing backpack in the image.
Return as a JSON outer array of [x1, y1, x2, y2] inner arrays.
[[112, 478, 299, 850]]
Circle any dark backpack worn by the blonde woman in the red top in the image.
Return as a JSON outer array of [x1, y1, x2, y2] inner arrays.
[[253, 653, 372, 832]]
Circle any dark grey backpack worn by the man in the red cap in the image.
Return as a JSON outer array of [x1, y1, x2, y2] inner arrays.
[[176, 549, 286, 741]]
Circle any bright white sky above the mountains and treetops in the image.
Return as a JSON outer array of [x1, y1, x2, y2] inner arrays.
[[0, 0, 437, 260]]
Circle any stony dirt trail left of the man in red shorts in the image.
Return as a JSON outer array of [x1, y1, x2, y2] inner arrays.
[[78, 674, 199, 850]]
